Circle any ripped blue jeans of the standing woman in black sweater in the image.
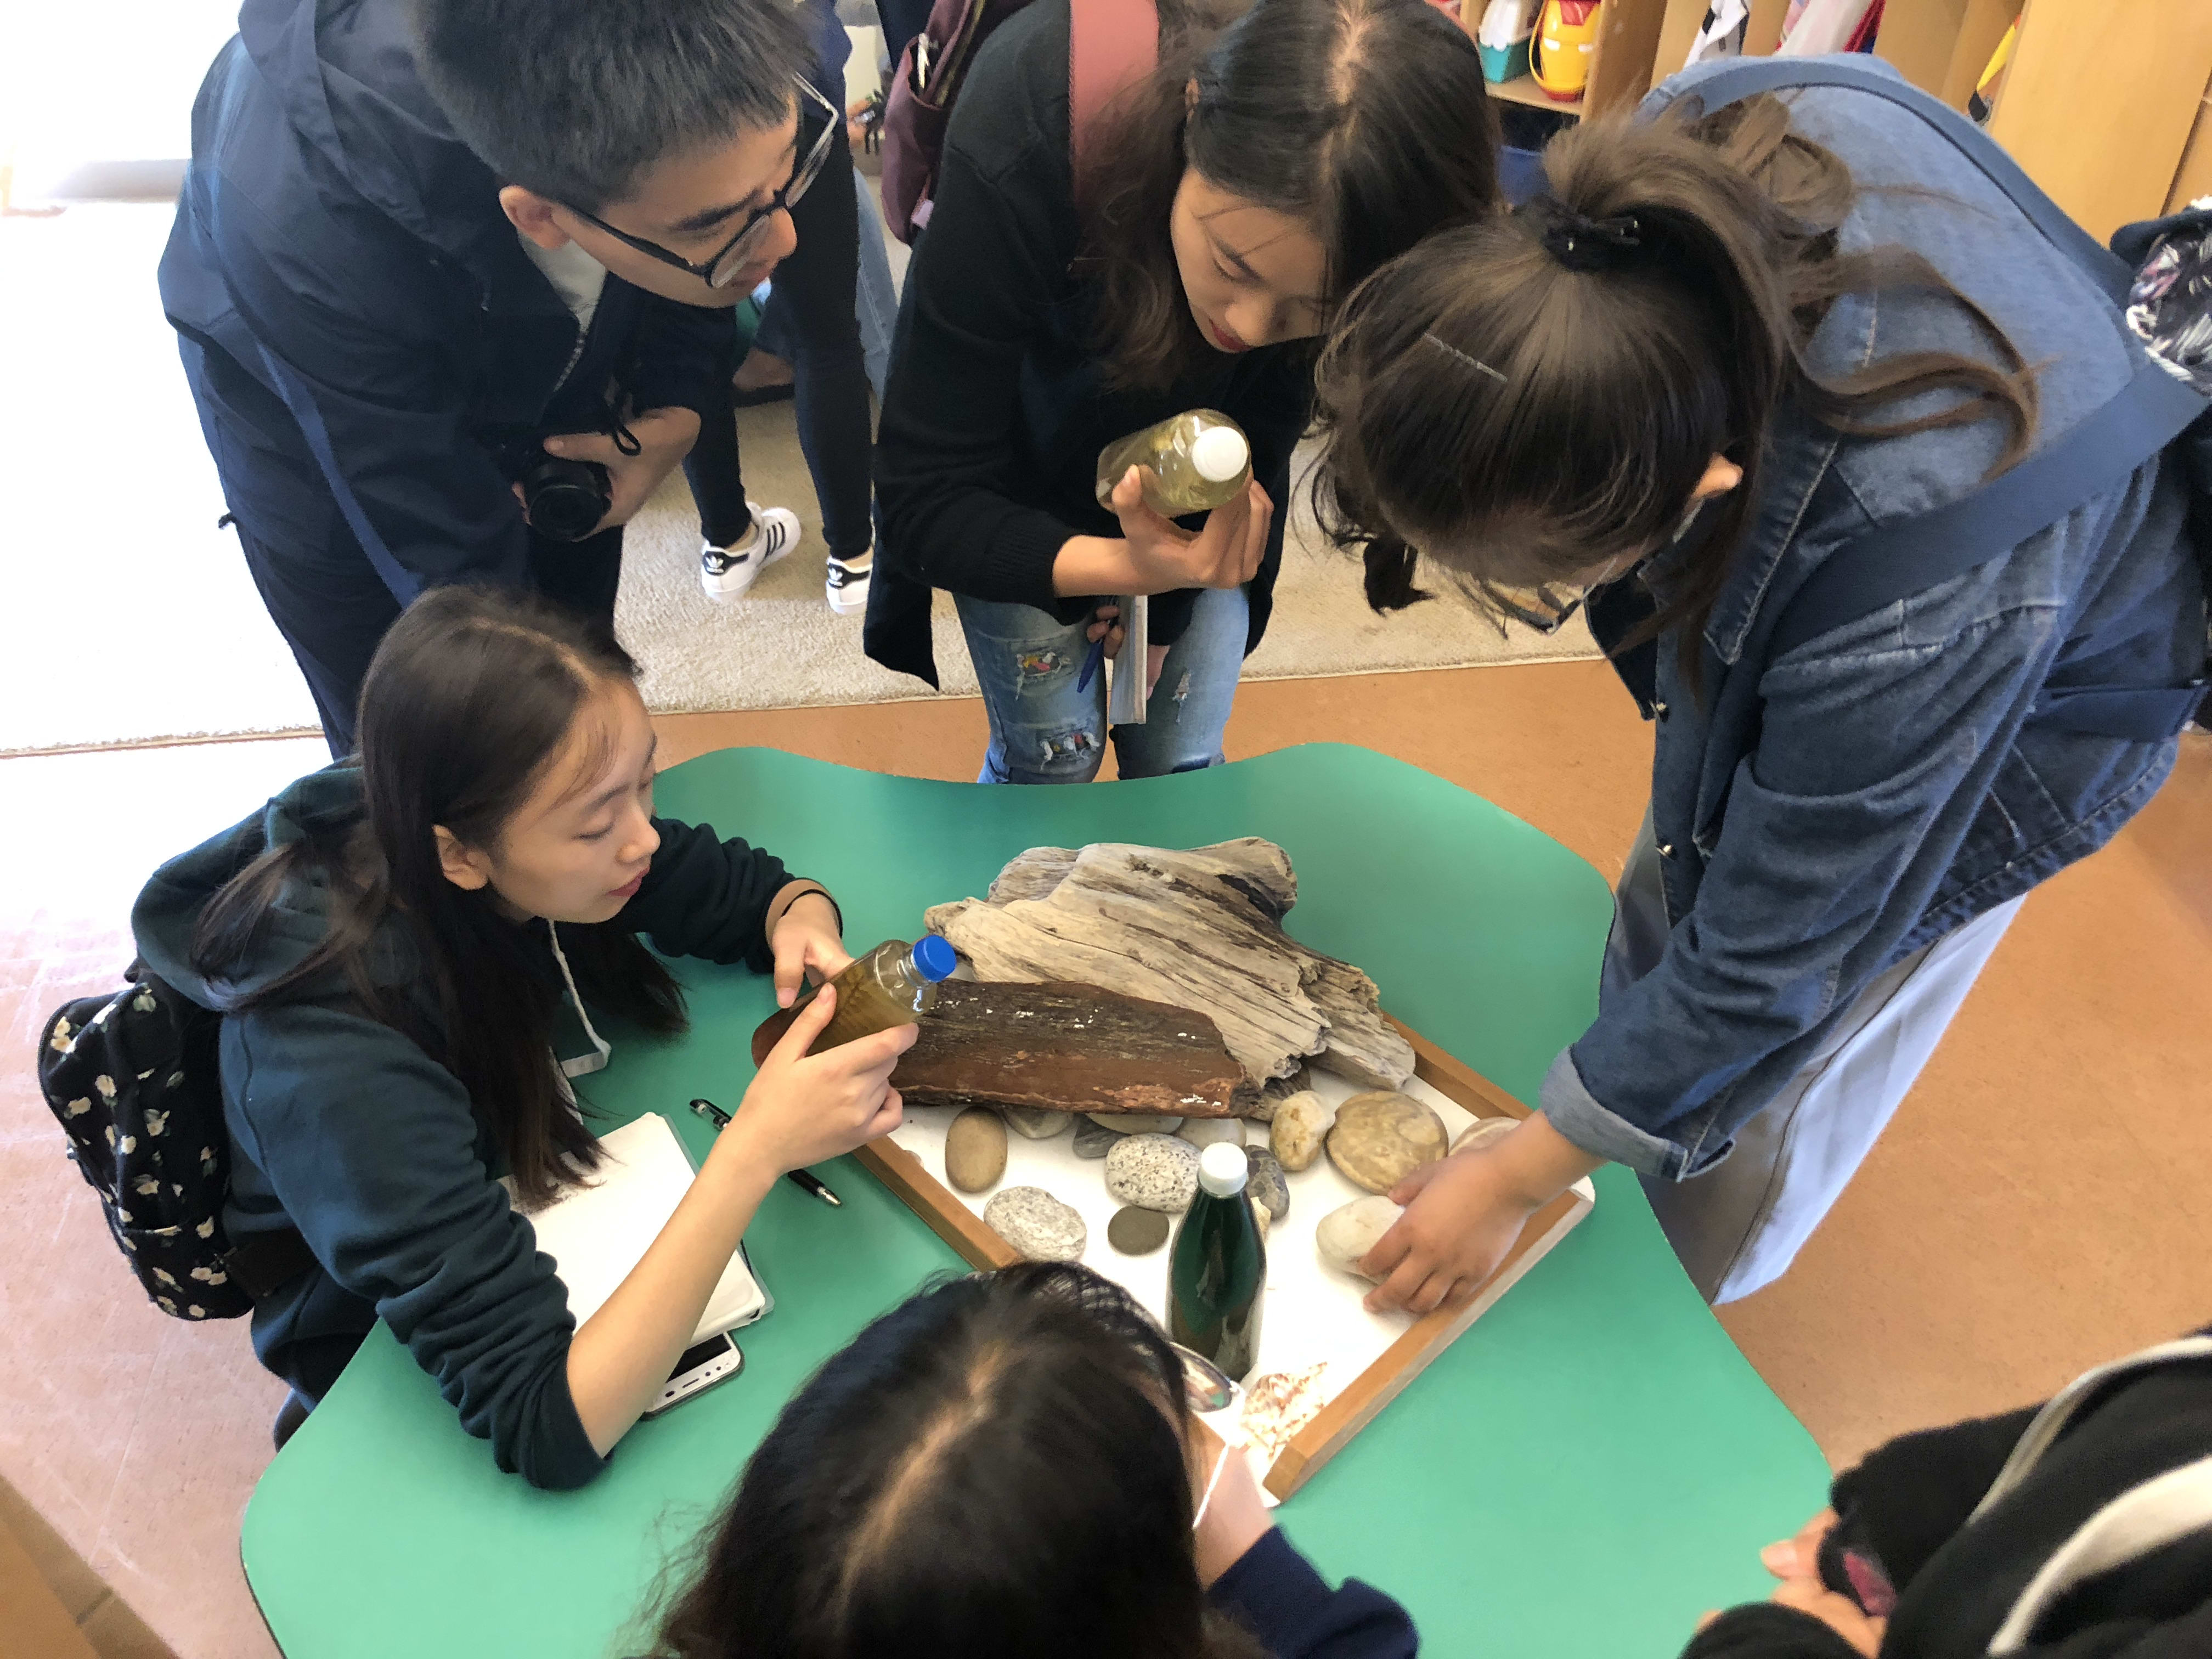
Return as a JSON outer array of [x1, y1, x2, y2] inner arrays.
[[953, 589, 1250, 783]]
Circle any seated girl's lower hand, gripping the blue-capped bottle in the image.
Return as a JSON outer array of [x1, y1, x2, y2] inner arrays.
[[710, 986, 920, 1175]]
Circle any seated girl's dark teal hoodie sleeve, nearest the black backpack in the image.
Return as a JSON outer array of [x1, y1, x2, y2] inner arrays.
[[223, 1005, 604, 1489]]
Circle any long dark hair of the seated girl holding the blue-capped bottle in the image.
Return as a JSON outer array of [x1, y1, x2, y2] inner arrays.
[[193, 586, 684, 1203]]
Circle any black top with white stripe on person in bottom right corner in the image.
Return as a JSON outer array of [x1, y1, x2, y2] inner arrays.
[[1683, 1345, 2212, 1659]]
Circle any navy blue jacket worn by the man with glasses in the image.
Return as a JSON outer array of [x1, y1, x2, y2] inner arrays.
[[161, 0, 735, 602]]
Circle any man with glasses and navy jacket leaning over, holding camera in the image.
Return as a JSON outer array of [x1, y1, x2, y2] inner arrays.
[[161, 0, 843, 754]]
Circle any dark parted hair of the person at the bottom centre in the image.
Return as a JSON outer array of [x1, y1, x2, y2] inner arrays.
[[654, 1263, 1261, 1659]]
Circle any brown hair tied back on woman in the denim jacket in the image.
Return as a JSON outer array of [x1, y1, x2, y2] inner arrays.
[[1316, 97, 2037, 668]]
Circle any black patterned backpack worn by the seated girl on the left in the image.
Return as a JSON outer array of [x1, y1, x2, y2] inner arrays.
[[38, 962, 314, 1318]]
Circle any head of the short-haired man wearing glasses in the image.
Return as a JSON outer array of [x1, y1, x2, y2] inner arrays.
[[411, 0, 827, 305]]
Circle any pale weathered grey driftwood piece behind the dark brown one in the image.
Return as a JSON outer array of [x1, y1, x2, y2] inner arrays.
[[927, 836, 1413, 1088]]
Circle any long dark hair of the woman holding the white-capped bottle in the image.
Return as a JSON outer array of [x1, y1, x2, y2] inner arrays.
[[1077, 0, 1498, 390]]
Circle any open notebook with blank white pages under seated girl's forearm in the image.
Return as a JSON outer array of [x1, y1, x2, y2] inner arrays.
[[500, 1113, 772, 1342]]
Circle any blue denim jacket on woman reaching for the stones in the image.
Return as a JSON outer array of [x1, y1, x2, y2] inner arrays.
[[1542, 71, 2205, 1179]]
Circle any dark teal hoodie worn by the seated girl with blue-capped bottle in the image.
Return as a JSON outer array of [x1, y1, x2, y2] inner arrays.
[[131, 765, 789, 1487]]
